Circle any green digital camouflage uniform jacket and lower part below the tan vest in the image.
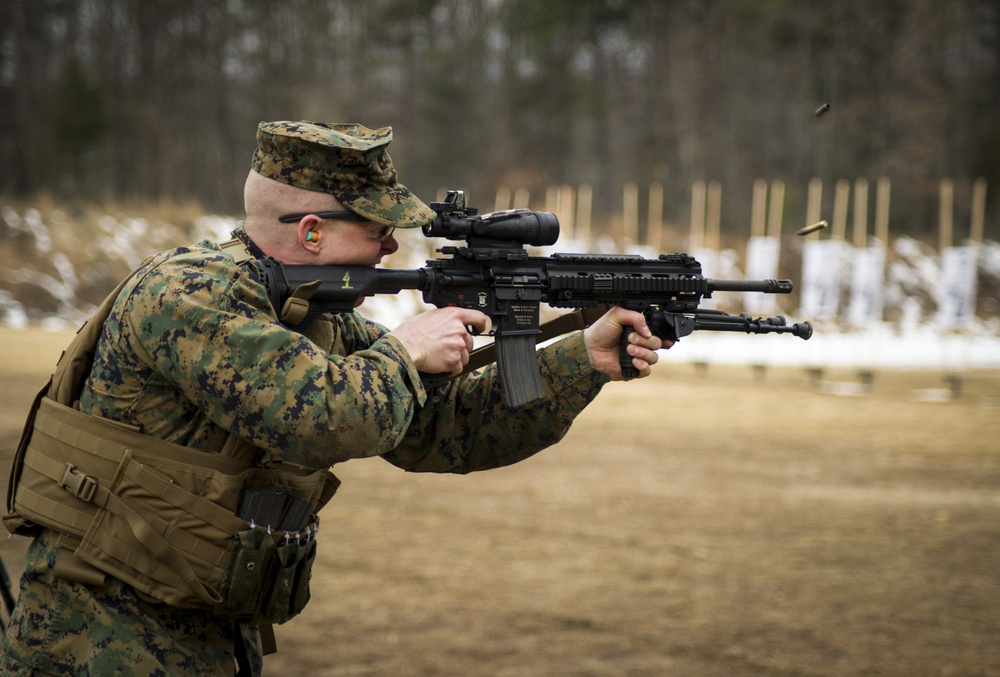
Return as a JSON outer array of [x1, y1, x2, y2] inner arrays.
[[0, 123, 607, 675]]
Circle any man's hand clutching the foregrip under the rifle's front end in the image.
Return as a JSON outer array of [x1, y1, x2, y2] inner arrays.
[[583, 307, 674, 381]]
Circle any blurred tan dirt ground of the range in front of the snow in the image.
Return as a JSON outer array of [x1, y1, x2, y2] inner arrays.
[[0, 330, 1000, 677]]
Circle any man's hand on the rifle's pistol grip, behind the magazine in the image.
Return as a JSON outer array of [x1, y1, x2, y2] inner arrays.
[[389, 307, 489, 376]]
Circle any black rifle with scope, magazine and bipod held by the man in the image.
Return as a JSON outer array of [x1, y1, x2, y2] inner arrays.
[[253, 191, 812, 407]]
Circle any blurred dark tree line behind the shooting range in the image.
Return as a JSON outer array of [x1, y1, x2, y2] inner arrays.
[[0, 0, 1000, 237]]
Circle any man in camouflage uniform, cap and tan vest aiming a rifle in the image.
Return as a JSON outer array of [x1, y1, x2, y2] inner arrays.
[[0, 122, 669, 675]]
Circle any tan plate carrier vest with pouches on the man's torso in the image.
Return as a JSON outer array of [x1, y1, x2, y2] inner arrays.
[[3, 246, 340, 625]]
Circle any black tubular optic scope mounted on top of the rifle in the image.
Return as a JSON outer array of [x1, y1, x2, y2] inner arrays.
[[424, 205, 559, 247]]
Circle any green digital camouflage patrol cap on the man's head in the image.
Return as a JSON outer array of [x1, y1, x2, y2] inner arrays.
[[252, 121, 435, 228]]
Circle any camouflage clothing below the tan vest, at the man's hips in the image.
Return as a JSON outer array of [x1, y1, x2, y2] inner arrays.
[[0, 530, 263, 677]]
